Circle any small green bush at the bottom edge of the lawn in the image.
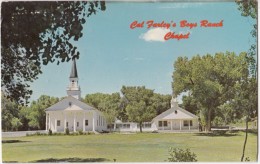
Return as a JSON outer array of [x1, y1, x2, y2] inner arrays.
[[168, 147, 198, 162]]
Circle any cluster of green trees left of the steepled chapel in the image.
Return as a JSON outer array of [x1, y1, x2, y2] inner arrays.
[[1, 94, 59, 131]]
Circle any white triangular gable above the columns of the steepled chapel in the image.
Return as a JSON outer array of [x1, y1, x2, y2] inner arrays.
[[45, 96, 96, 111]]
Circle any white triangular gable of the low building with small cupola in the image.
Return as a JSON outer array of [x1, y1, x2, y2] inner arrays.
[[152, 106, 198, 121]]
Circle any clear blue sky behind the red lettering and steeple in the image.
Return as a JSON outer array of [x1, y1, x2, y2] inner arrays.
[[31, 2, 253, 100]]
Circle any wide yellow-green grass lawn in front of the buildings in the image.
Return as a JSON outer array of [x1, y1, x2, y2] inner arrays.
[[2, 132, 257, 162]]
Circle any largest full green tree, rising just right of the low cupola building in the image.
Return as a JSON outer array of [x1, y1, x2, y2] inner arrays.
[[173, 52, 248, 131]]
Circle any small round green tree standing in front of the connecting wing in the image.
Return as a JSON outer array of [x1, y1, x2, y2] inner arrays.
[[121, 86, 156, 132]]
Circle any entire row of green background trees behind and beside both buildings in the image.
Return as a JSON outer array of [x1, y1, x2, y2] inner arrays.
[[2, 52, 257, 131]]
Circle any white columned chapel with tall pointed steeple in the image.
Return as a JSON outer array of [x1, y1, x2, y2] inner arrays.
[[45, 60, 107, 132]]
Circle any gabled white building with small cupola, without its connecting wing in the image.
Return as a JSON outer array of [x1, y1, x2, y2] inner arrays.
[[152, 98, 199, 131]]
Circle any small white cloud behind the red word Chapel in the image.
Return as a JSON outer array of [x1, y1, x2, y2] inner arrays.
[[139, 28, 170, 42]]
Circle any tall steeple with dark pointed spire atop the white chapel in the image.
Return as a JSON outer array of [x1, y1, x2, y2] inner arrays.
[[67, 59, 81, 100]]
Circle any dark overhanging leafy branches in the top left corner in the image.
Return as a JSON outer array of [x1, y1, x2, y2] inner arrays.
[[1, 1, 105, 103]]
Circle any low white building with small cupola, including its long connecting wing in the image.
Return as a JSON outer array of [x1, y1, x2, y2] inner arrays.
[[110, 98, 199, 132]]
